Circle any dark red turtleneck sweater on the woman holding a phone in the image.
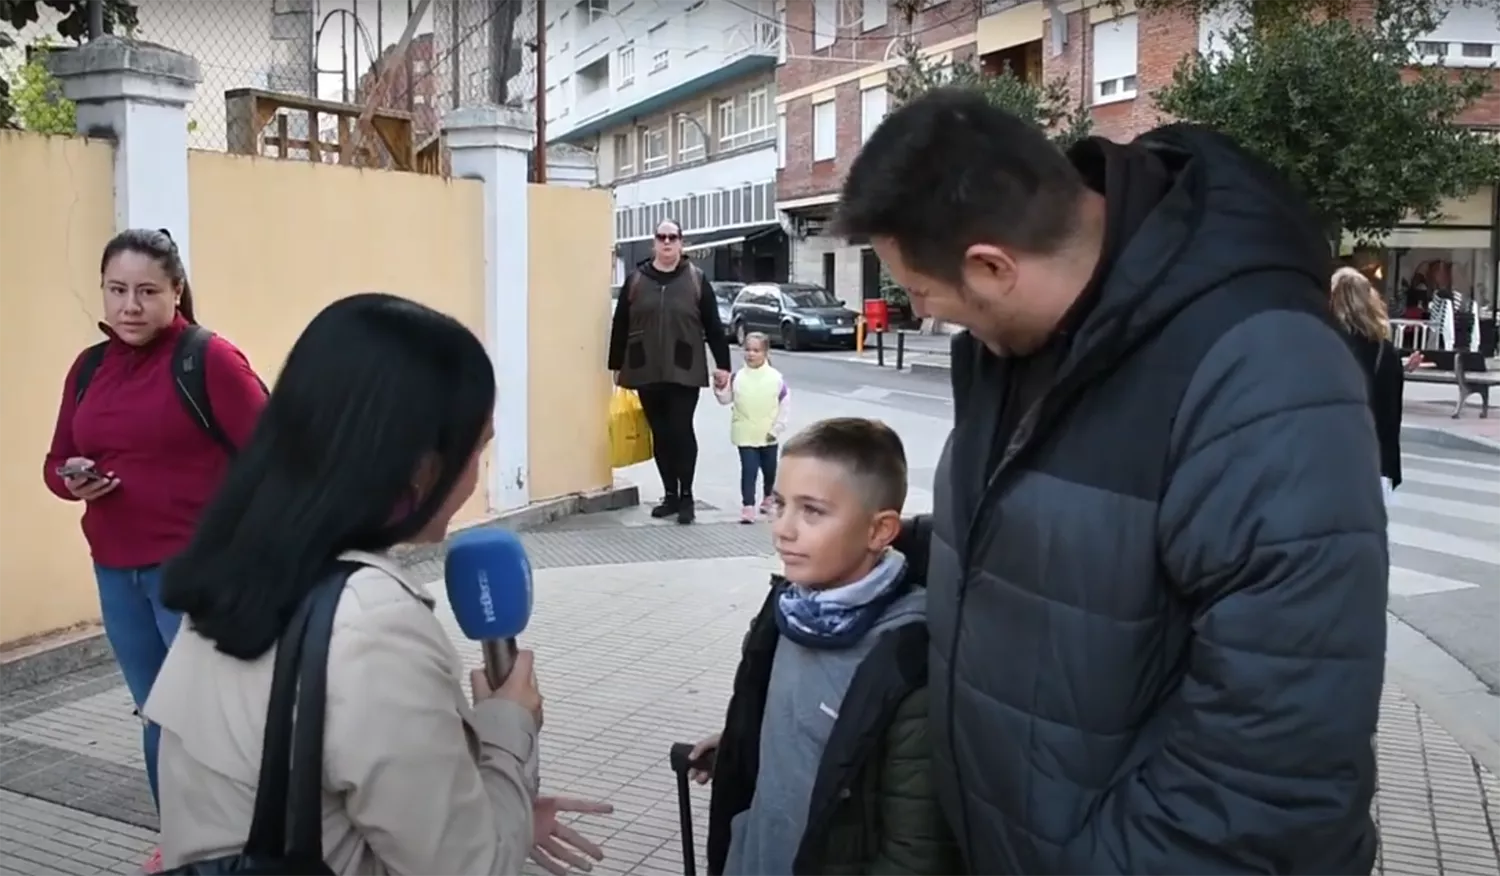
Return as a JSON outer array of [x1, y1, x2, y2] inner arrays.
[[42, 317, 266, 569]]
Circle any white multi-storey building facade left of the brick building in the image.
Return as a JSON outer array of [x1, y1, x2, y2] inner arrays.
[[546, 0, 788, 281]]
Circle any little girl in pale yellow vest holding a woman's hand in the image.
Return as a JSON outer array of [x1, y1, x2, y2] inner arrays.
[[714, 332, 792, 524]]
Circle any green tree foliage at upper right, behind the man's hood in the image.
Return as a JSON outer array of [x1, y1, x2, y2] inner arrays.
[[1148, 8, 1500, 240]]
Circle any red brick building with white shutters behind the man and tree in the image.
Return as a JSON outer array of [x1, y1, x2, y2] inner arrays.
[[777, 0, 1500, 321]]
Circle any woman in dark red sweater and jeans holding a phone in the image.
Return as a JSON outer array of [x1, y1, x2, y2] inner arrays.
[[42, 230, 266, 870]]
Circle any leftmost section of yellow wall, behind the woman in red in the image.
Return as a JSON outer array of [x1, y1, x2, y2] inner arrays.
[[0, 131, 114, 644]]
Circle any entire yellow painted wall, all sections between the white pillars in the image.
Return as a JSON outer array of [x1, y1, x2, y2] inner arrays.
[[0, 144, 614, 647]]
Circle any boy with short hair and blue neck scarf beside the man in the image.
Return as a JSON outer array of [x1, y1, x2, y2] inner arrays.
[[695, 417, 960, 876]]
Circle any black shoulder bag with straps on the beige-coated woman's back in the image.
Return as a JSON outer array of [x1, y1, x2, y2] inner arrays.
[[162, 563, 360, 876]]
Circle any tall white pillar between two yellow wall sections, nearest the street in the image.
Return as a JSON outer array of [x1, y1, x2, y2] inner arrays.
[[443, 107, 536, 512]]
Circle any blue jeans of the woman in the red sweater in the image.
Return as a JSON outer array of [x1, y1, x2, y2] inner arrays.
[[95, 563, 180, 800]]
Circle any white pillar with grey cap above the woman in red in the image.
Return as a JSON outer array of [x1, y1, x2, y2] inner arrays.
[[47, 36, 203, 270]]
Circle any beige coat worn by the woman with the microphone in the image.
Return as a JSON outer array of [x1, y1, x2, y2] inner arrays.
[[146, 552, 537, 876]]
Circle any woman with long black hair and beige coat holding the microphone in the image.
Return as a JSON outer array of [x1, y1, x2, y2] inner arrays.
[[146, 294, 606, 876]]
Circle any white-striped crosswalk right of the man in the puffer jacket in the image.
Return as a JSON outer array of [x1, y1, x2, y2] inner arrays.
[[1388, 453, 1500, 597]]
